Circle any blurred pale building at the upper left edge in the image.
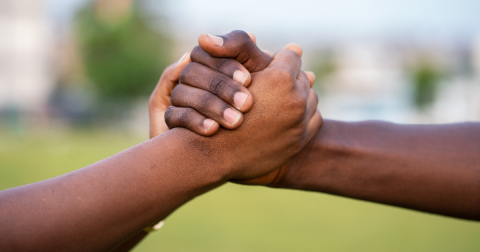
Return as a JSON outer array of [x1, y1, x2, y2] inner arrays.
[[0, 0, 55, 113]]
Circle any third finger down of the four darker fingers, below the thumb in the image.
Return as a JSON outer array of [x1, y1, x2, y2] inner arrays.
[[171, 84, 243, 129]]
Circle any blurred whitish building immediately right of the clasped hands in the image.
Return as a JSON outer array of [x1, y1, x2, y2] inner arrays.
[[320, 41, 410, 122]]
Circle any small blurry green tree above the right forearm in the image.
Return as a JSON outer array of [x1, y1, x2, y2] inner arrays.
[[409, 60, 445, 110]]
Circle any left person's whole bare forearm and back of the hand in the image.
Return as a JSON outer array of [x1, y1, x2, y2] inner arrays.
[[0, 42, 321, 251]]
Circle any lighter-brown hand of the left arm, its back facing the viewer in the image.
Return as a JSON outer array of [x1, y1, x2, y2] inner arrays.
[[172, 45, 322, 182]]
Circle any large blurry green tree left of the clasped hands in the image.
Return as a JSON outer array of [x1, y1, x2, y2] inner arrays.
[[76, 0, 172, 103]]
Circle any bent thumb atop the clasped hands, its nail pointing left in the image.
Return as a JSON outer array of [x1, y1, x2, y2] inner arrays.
[[198, 31, 272, 73]]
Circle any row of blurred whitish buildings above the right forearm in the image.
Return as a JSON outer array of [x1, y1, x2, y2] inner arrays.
[[317, 36, 480, 123]]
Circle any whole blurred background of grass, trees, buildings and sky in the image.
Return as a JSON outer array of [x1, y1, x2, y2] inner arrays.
[[0, 0, 480, 251]]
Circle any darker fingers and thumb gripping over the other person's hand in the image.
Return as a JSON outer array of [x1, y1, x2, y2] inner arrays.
[[165, 31, 315, 136]]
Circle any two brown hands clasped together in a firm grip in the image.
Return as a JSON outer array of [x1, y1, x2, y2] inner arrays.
[[149, 31, 322, 185]]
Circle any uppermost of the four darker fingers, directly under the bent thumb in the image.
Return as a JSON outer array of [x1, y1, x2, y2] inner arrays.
[[190, 46, 252, 87]]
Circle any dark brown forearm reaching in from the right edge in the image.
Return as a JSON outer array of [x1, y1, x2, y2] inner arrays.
[[279, 120, 480, 220]]
